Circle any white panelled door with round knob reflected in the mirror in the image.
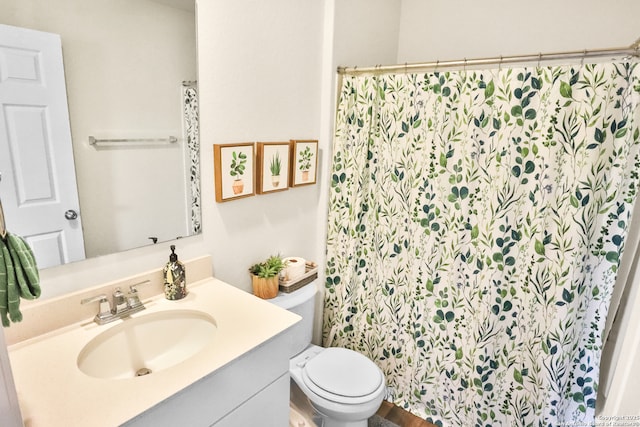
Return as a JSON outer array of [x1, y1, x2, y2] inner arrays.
[[0, 25, 85, 268]]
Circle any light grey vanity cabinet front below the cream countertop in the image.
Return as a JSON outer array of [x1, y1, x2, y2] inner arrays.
[[123, 329, 291, 427]]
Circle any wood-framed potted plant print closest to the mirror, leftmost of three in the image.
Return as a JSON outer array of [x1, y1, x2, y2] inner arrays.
[[213, 142, 255, 202]]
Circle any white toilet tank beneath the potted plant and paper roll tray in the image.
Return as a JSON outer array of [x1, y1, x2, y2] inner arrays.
[[267, 282, 317, 358]]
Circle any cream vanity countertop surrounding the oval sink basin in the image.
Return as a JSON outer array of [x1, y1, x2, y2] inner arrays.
[[9, 278, 300, 427]]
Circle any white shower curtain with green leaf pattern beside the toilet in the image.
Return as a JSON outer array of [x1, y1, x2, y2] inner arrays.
[[323, 63, 640, 427]]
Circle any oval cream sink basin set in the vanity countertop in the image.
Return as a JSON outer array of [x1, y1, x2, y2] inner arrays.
[[77, 310, 217, 379]]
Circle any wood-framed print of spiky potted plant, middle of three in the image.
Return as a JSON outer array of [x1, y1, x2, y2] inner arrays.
[[256, 142, 290, 194]]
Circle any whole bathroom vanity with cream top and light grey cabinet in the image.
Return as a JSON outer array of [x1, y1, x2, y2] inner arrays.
[[9, 262, 299, 427]]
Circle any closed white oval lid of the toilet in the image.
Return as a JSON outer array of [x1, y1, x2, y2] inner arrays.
[[304, 347, 384, 398]]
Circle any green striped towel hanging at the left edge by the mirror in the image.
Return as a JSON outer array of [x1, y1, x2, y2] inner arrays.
[[0, 233, 40, 327]]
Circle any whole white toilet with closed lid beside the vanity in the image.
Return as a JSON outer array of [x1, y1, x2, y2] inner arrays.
[[269, 283, 385, 427]]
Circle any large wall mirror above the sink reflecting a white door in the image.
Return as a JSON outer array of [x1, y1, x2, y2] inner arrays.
[[0, 0, 201, 268]]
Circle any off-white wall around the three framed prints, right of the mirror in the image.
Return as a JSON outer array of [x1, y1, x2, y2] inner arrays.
[[198, 0, 328, 290]]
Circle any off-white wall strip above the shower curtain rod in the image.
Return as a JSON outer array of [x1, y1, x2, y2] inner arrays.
[[397, 0, 640, 63]]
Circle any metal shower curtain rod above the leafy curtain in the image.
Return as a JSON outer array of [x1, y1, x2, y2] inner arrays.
[[338, 39, 640, 75]]
